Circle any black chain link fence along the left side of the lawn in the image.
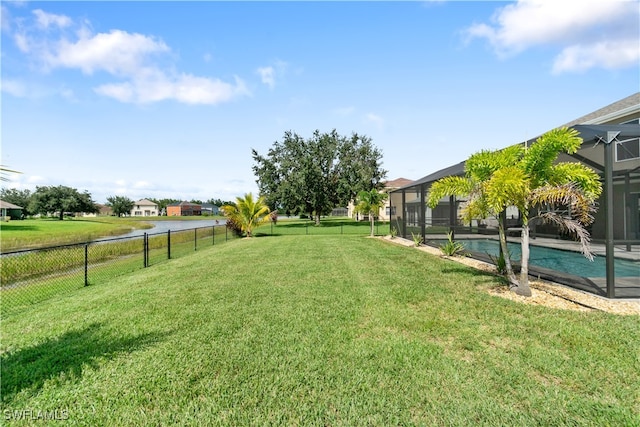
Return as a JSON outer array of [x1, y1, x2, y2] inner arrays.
[[0, 225, 237, 316]]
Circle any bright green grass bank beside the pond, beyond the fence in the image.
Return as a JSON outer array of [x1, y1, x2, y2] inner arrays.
[[0, 217, 151, 252]]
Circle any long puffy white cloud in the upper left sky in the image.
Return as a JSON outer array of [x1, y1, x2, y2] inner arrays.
[[3, 9, 251, 105]]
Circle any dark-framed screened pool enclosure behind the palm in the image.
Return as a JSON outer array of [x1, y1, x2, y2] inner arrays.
[[390, 124, 640, 298]]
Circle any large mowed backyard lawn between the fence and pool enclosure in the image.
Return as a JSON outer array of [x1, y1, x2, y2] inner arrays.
[[1, 235, 640, 426]]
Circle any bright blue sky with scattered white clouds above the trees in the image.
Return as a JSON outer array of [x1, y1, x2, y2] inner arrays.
[[1, 0, 640, 202]]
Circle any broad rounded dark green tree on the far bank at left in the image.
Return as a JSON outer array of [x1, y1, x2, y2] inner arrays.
[[29, 185, 98, 220]]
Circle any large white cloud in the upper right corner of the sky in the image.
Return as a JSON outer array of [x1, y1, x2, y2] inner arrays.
[[465, 0, 640, 72]]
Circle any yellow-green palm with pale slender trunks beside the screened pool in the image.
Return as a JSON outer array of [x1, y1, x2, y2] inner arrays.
[[429, 128, 602, 296]]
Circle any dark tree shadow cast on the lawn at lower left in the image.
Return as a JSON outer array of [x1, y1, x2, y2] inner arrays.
[[0, 323, 166, 405]]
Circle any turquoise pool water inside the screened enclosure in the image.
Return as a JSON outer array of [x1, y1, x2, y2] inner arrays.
[[430, 239, 640, 278]]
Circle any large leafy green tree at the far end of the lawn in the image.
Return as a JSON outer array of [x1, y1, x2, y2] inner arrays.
[[252, 129, 386, 224]]
